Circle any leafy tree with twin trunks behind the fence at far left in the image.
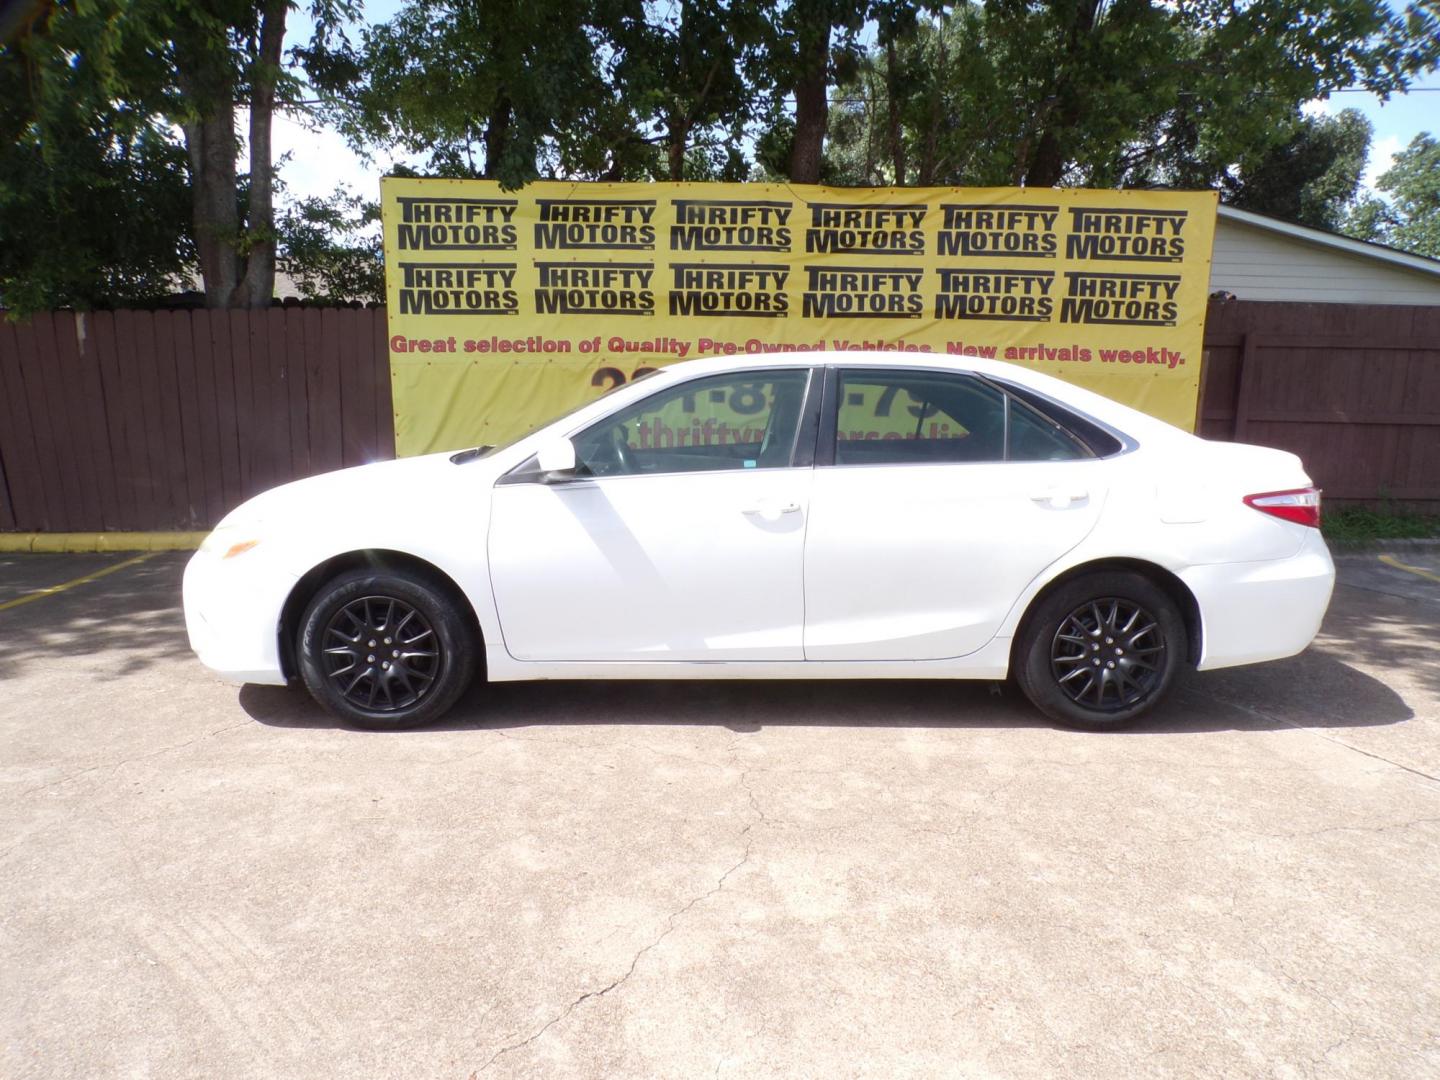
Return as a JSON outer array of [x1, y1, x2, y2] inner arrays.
[[7, 0, 356, 307]]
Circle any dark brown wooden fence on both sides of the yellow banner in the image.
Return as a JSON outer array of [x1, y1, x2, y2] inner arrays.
[[0, 301, 1440, 531]]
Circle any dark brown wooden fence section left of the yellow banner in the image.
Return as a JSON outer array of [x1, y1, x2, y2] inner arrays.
[[0, 308, 395, 531]]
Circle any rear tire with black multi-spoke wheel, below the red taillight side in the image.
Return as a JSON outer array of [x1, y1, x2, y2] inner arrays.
[[1015, 570, 1189, 732]]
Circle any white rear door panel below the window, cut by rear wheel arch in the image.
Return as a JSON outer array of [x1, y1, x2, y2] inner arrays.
[[805, 461, 1104, 660]]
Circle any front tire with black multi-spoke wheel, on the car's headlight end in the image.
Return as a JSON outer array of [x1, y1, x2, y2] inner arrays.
[[295, 570, 478, 732]]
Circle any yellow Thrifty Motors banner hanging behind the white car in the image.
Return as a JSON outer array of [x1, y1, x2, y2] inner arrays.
[[382, 179, 1215, 455]]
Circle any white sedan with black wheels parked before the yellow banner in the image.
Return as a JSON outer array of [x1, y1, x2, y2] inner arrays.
[[184, 353, 1335, 729]]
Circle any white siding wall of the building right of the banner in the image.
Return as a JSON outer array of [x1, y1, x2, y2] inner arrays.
[[1210, 217, 1440, 304]]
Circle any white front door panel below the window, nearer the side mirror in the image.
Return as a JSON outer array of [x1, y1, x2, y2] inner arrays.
[[490, 468, 811, 661]]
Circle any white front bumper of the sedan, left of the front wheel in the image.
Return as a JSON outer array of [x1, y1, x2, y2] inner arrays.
[[183, 550, 297, 685]]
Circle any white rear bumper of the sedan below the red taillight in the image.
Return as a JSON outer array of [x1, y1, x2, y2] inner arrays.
[[1179, 528, 1335, 671]]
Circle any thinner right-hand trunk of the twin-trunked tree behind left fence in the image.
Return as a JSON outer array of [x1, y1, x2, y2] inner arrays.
[[230, 0, 289, 308]]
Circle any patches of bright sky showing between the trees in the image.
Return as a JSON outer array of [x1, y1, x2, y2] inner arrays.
[[272, 0, 1440, 199]]
